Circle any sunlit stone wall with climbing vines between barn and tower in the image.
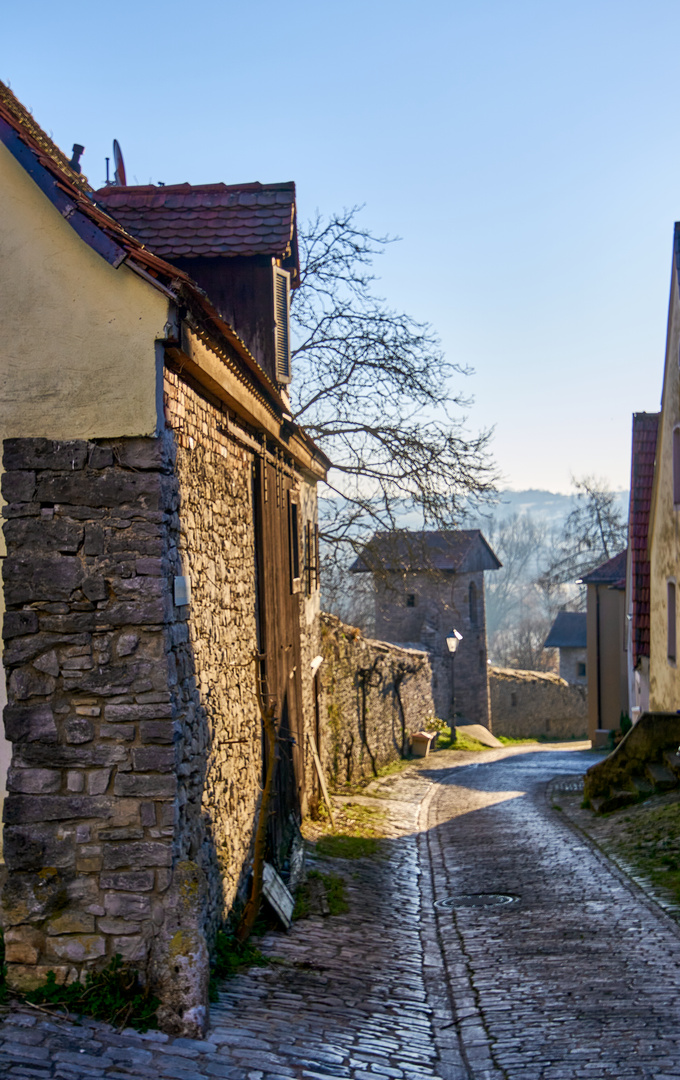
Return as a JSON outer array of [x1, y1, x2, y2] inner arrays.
[[321, 615, 434, 784]]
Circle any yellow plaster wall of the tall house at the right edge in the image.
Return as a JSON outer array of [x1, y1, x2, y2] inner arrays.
[[650, 258, 680, 713]]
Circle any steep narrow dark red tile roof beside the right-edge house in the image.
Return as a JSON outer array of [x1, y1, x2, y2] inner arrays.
[[628, 413, 659, 667]]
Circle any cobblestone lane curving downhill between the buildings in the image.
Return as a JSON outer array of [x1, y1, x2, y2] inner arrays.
[[0, 747, 680, 1080]]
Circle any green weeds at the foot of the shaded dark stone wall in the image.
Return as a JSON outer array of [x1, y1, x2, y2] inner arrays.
[[24, 955, 161, 1031]]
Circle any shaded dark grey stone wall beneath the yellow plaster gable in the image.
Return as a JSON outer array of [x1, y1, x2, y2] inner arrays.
[[2, 429, 194, 1002]]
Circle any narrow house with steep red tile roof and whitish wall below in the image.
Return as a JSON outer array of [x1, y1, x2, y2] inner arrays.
[[626, 413, 659, 721]]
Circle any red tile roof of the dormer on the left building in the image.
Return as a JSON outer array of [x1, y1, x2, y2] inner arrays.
[[95, 183, 297, 261]]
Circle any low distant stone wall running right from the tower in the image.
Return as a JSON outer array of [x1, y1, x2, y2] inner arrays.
[[489, 667, 588, 739]]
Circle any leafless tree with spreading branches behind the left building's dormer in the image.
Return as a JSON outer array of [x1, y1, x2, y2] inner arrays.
[[291, 206, 495, 587]]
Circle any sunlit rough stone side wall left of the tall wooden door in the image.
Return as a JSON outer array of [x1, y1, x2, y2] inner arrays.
[[165, 370, 262, 939]]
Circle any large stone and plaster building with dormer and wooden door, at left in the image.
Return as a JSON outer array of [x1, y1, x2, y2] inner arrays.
[[0, 85, 328, 1034]]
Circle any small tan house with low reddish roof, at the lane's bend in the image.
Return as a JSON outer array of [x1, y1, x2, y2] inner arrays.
[[582, 551, 628, 740]]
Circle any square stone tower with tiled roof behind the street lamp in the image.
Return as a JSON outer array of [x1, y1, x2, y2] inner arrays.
[[352, 529, 501, 727]]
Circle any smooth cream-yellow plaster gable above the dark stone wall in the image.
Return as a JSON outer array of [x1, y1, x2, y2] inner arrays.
[[0, 144, 167, 438]]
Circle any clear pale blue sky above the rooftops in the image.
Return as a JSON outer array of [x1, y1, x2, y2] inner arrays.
[[0, 0, 680, 491]]
